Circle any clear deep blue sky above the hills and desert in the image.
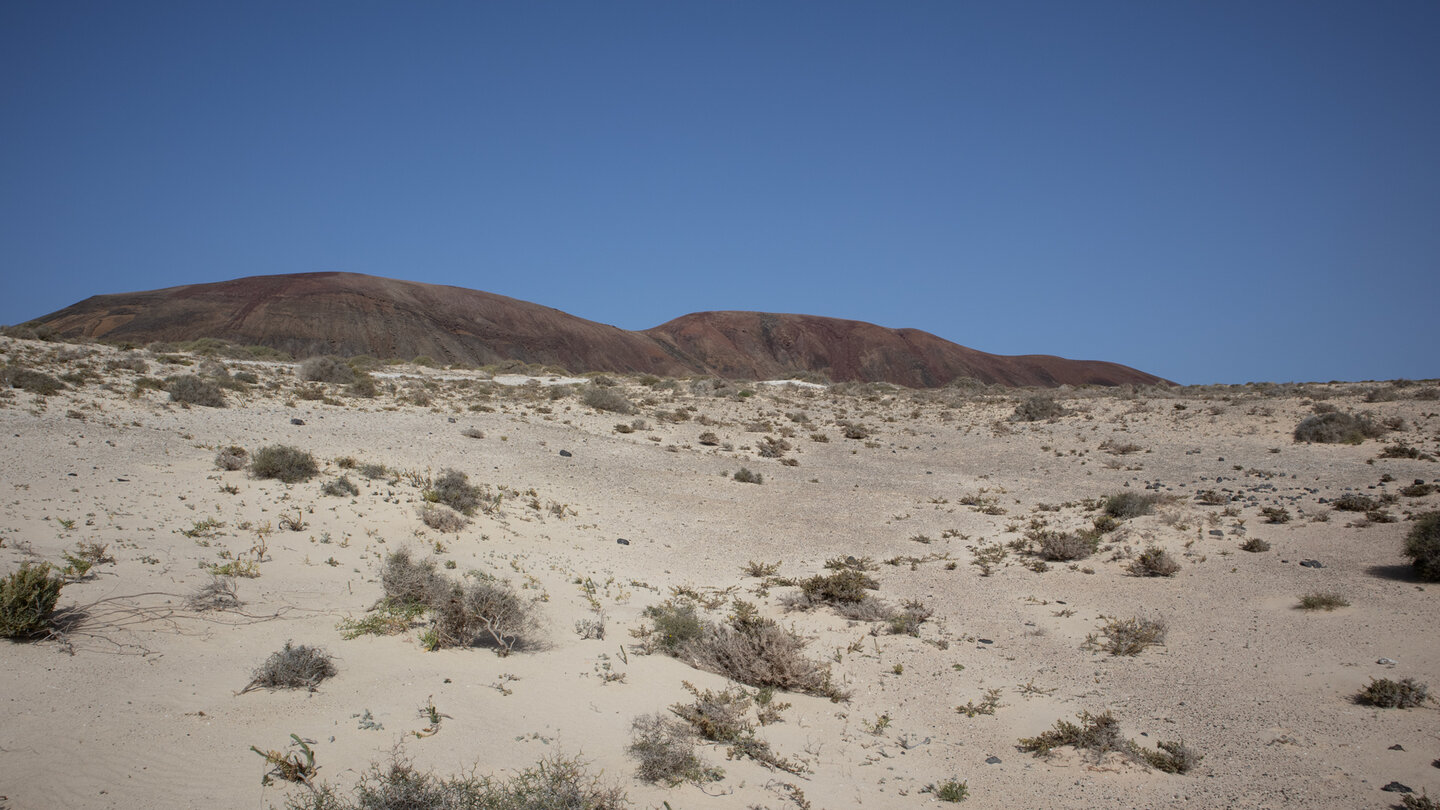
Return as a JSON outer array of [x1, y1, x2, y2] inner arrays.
[[0, 0, 1440, 383]]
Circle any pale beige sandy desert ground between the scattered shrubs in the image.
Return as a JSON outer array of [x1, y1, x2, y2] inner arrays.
[[0, 332, 1440, 810]]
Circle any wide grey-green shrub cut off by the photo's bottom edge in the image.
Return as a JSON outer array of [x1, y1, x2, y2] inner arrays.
[[285, 752, 629, 810]]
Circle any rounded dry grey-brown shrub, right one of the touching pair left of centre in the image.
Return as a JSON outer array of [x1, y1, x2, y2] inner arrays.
[[431, 570, 539, 656]]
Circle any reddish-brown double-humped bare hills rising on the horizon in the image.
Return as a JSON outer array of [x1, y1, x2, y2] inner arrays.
[[30, 272, 1164, 388]]
